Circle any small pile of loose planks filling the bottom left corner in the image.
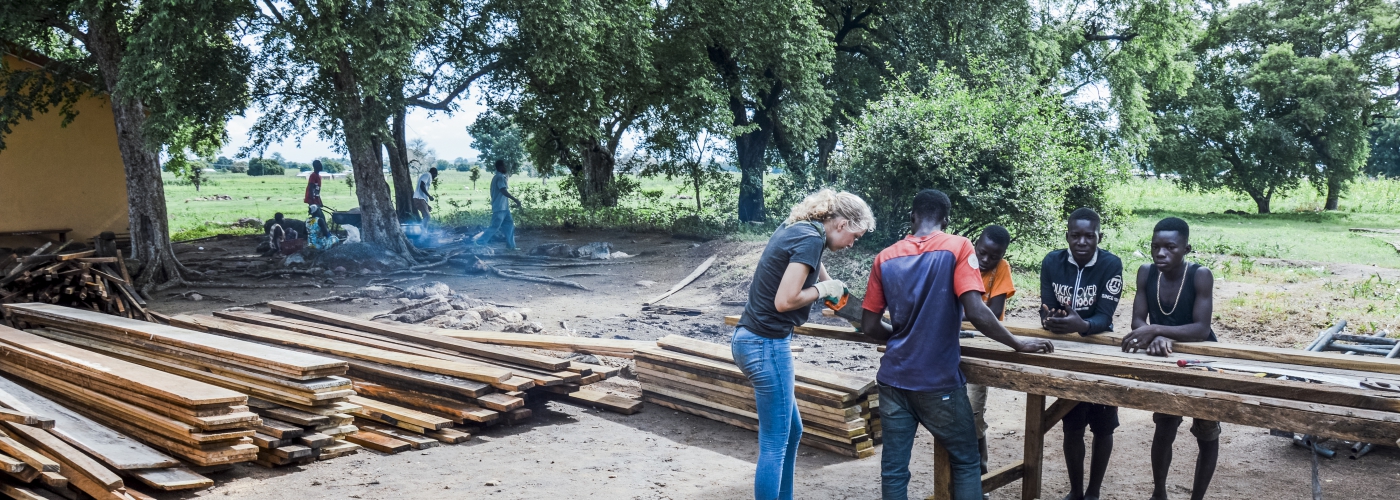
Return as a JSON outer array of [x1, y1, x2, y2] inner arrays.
[[0, 377, 214, 499]]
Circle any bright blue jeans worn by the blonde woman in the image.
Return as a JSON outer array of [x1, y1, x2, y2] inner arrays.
[[729, 326, 800, 500]]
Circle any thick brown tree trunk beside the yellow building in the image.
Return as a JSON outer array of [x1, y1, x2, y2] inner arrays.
[[83, 11, 189, 294]]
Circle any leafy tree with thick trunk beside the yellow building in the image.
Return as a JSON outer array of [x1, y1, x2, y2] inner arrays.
[[0, 0, 253, 293]]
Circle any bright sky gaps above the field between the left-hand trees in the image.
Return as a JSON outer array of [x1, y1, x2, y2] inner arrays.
[[220, 99, 486, 162]]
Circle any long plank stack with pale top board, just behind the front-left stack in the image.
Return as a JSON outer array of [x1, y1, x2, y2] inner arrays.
[[0, 304, 358, 465]]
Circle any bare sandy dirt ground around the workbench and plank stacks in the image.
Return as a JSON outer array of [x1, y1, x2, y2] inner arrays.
[[133, 231, 1400, 500]]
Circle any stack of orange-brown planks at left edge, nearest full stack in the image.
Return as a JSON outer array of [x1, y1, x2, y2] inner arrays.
[[0, 320, 259, 465]]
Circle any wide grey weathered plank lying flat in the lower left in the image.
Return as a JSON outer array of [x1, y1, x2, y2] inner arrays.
[[0, 377, 214, 492]]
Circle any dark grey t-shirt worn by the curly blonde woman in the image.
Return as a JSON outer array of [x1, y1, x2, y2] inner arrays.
[[739, 221, 826, 339]]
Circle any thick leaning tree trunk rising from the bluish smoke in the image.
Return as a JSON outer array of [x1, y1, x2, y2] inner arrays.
[[335, 52, 417, 262]]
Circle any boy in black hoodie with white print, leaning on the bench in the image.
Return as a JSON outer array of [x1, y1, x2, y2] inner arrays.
[[1040, 209, 1123, 500]]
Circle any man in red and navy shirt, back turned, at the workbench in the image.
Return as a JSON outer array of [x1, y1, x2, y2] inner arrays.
[[856, 189, 1054, 500]]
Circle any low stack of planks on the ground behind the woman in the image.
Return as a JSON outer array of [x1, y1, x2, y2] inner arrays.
[[636, 335, 881, 458]]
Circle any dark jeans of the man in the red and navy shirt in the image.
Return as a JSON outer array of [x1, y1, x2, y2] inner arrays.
[[879, 384, 981, 500]]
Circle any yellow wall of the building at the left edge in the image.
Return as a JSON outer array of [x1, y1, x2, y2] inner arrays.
[[0, 53, 127, 246]]
